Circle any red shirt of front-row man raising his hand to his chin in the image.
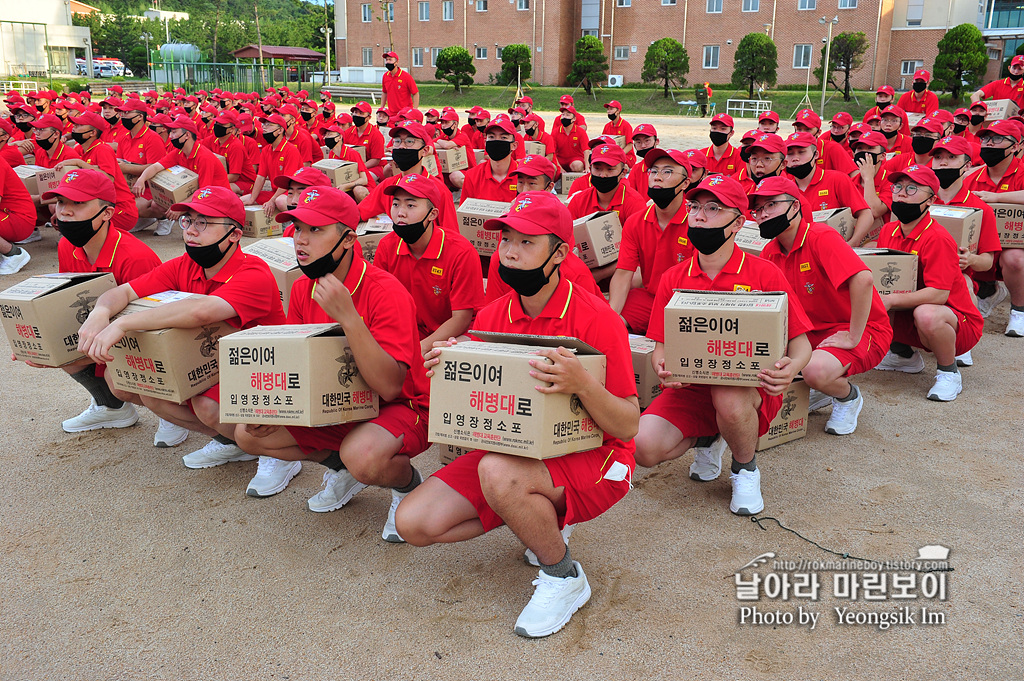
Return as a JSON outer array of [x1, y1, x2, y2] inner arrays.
[[288, 253, 430, 410]]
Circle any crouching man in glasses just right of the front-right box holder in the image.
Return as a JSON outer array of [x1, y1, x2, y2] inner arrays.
[[750, 177, 893, 435]]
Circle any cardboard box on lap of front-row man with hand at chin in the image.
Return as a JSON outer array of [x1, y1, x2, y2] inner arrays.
[[220, 324, 380, 426]]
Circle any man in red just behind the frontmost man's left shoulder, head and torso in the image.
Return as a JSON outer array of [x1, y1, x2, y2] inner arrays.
[[374, 175, 483, 354]]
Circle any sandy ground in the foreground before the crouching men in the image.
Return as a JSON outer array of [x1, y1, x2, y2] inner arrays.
[[0, 118, 1024, 680]]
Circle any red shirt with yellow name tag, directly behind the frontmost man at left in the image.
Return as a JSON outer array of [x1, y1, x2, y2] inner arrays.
[[374, 224, 483, 340]]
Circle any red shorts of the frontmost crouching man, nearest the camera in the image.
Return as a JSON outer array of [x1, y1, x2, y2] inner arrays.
[[433, 444, 636, 531]]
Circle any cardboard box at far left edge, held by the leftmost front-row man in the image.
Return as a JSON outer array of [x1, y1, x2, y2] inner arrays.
[[0, 272, 117, 367]]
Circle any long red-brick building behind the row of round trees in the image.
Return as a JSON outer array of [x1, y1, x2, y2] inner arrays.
[[335, 0, 1024, 94]]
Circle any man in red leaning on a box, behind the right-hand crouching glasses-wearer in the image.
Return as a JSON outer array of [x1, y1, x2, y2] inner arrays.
[[785, 133, 873, 246]]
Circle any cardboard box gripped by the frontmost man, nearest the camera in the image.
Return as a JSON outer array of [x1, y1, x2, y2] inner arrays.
[[429, 332, 605, 459]]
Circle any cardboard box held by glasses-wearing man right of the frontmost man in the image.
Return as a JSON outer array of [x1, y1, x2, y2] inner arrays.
[[665, 291, 788, 386]]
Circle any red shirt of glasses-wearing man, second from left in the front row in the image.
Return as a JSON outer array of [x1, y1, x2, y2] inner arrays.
[[129, 244, 285, 329]]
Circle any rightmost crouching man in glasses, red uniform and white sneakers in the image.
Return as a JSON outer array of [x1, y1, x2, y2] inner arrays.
[[876, 166, 984, 401]]
